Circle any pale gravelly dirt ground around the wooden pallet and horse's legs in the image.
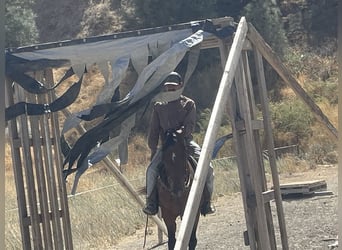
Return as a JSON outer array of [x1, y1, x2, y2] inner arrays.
[[111, 165, 338, 250]]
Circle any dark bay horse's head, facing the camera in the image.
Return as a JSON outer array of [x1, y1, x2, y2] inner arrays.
[[162, 129, 189, 196]]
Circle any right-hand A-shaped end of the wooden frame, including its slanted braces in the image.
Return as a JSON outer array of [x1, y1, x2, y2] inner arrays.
[[175, 17, 337, 250]]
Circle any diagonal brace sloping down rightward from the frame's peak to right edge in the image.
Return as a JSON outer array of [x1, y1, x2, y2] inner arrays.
[[247, 23, 338, 139]]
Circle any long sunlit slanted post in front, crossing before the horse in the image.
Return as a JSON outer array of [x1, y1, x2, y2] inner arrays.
[[175, 18, 247, 249]]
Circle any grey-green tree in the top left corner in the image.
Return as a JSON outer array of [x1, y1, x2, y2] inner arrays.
[[5, 0, 38, 47]]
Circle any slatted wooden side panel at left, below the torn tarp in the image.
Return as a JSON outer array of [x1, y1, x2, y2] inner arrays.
[[6, 70, 73, 249]]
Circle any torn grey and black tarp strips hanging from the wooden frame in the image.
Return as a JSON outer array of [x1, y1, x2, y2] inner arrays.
[[6, 20, 234, 191]]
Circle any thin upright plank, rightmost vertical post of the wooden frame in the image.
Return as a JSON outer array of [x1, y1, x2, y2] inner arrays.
[[253, 47, 289, 250]]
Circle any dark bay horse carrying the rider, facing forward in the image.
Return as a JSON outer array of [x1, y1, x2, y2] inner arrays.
[[157, 130, 203, 249]]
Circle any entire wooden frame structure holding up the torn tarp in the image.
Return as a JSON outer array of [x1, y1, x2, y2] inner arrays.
[[6, 17, 337, 250]]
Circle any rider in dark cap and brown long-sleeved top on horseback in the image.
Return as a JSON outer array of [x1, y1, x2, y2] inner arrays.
[[143, 72, 215, 215]]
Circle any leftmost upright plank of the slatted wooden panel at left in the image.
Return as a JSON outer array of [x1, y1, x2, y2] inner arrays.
[[5, 78, 31, 250]]
